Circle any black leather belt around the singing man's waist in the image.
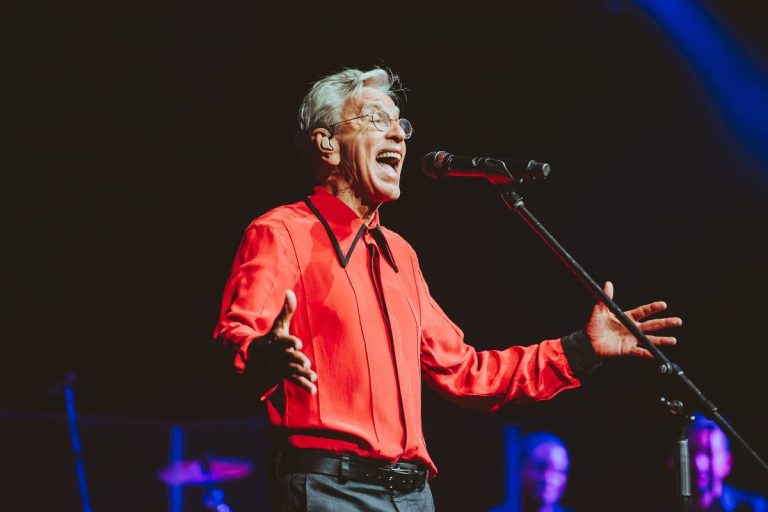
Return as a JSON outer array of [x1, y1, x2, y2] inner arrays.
[[275, 449, 427, 492]]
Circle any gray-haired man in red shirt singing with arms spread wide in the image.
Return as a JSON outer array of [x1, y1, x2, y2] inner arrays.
[[214, 68, 681, 511]]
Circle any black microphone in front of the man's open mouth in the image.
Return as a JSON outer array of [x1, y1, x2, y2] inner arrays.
[[421, 151, 552, 184]]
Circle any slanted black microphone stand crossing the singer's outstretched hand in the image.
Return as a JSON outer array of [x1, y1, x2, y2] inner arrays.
[[493, 182, 768, 510]]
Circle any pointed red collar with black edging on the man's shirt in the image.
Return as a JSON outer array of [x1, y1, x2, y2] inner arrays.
[[304, 185, 397, 272]]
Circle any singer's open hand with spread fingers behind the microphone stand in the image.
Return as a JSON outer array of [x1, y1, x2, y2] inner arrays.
[[587, 281, 683, 358]]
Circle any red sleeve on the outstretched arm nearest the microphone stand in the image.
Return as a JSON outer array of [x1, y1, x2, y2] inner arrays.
[[414, 256, 581, 411]]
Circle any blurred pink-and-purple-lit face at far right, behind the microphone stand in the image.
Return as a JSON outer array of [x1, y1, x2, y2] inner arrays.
[[688, 429, 731, 498]]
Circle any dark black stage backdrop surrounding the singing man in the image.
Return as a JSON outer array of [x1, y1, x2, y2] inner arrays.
[[6, 0, 768, 510]]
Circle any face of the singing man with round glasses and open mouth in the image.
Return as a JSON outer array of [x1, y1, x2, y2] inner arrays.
[[334, 87, 412, 206]]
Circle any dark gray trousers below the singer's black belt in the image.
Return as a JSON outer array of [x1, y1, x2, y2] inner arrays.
[[268, 473, 435, 512]]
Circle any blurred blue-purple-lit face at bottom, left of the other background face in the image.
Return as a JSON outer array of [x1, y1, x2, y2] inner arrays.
[[520, 443, 568, 505]]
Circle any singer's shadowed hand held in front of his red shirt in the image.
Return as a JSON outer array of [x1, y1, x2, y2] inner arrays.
[[248, 290, 317, 394]]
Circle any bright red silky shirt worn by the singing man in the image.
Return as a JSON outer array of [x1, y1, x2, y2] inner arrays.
[[214, 187, 580, 476]]
